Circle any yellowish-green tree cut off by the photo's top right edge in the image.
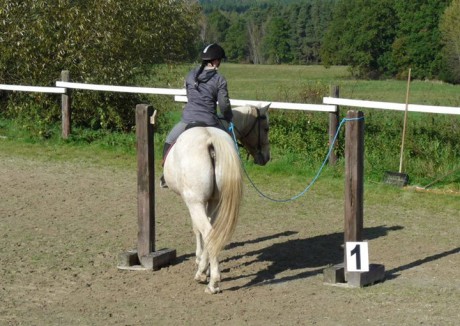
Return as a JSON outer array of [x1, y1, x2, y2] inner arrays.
[[440, 0, 460, 83]]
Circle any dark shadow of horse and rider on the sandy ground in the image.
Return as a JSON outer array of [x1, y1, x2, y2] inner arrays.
[[222, 226, 403, 290]]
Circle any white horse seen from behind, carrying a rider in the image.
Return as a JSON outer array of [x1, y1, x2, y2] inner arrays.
[[164, 105, 270, 294]]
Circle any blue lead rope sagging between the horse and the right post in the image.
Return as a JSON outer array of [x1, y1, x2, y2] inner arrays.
[[228, 117, 364, 203]]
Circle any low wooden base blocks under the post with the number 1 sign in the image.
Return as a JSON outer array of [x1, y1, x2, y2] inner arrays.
[[323, 263, 385, 287]]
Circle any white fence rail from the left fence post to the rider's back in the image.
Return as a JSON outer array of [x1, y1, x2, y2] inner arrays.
[[56, 81, 186, 95]]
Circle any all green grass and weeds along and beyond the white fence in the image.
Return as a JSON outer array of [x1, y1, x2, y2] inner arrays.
[[0, 63, 460, 191]]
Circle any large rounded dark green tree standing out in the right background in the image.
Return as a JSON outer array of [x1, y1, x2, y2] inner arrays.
[[321, 0, 398, 77]]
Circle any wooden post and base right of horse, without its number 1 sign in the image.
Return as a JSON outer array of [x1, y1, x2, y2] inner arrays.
[[324, 111, 385, 287]]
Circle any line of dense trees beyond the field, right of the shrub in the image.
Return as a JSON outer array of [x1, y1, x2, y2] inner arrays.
[[200, 0, 460, 83]]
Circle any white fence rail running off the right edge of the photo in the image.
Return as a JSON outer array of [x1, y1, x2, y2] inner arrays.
[[323, 97, 460, 115]]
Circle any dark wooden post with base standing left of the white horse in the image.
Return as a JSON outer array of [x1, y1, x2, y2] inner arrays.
[[118, 104, 176, 270]]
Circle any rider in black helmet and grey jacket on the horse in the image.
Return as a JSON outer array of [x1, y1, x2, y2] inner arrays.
[[160, 43, 233, 188]]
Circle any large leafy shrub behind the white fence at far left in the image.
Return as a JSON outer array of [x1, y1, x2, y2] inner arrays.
[[0, 0, 199, 134]]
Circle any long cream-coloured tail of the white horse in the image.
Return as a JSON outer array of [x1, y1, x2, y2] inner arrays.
[[206, 134, 243, 256]]
